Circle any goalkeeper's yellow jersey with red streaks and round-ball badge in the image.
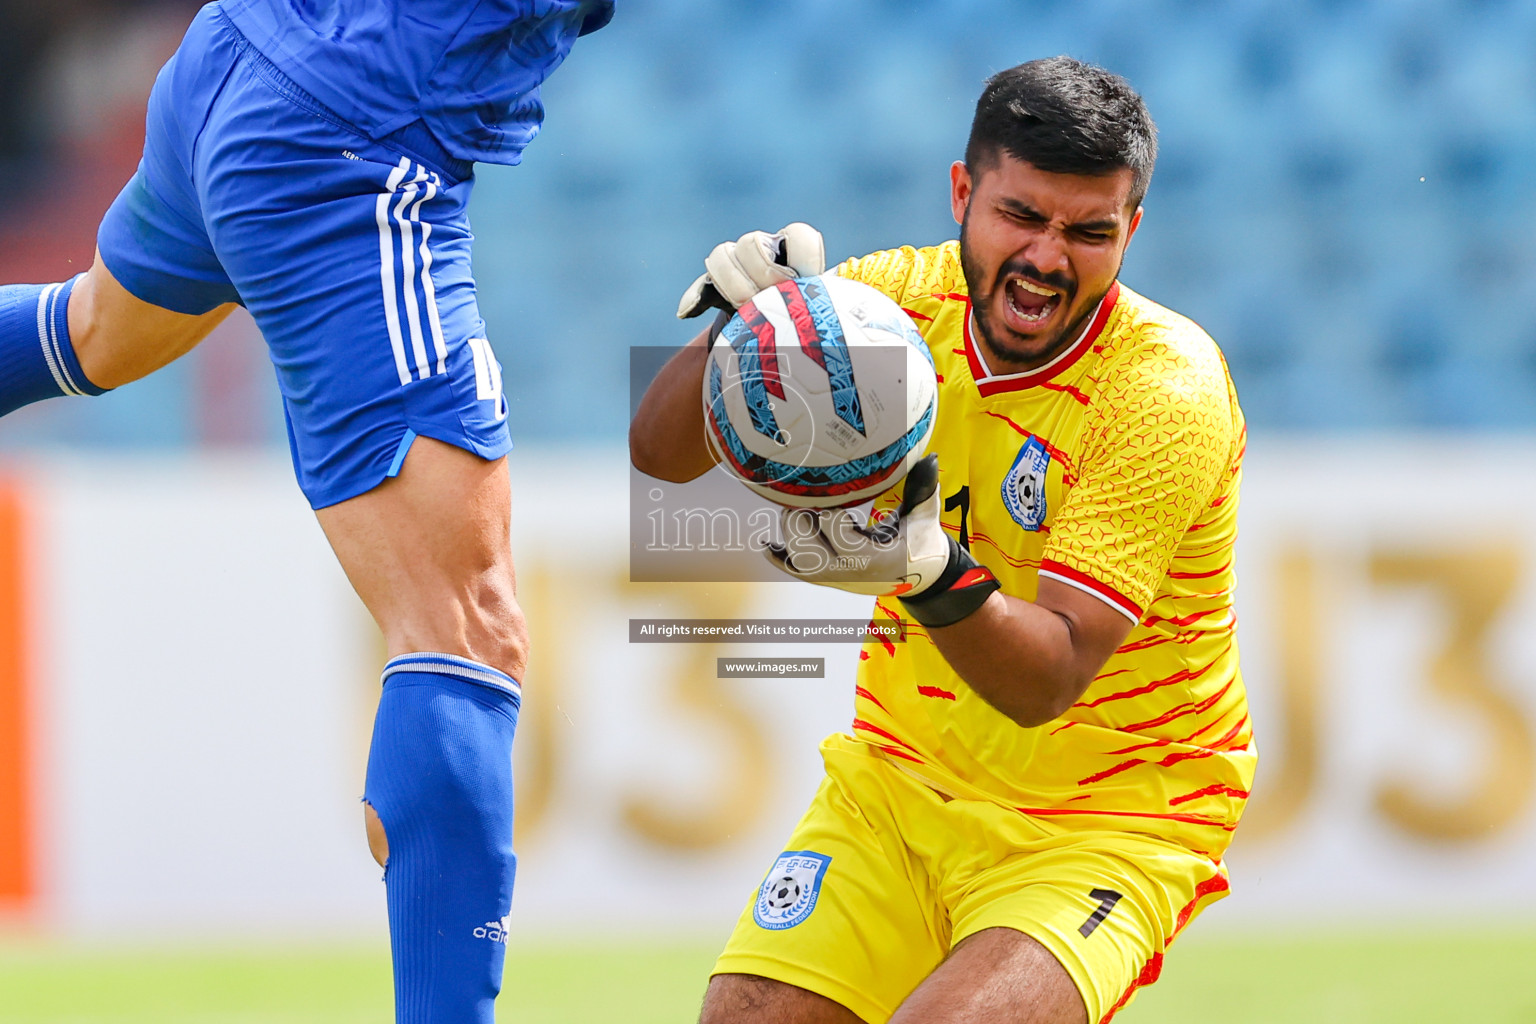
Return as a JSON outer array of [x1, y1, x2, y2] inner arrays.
[[837, 241, 1255, 860]]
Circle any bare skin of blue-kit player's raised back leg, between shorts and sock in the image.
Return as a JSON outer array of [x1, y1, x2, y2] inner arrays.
[[69, 253, 235, 388]]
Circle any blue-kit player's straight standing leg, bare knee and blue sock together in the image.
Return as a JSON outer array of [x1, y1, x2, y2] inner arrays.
[[316, 438, 528, 1024]]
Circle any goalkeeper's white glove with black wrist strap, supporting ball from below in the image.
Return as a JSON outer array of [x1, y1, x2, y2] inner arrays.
[[763, 454, 1000, 626]]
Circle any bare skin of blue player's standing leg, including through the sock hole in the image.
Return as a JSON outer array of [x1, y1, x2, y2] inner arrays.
[[316, 438, 528, 866]]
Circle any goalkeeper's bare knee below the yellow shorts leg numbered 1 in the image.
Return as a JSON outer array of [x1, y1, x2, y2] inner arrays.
[[891, 927, 1087, 1024]]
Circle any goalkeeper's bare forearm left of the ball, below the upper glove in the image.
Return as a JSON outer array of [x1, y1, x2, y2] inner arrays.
[[630, 330, 714, 484]]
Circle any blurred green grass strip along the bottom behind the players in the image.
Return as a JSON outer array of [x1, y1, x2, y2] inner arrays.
[[0, 927, 1536, 1024]]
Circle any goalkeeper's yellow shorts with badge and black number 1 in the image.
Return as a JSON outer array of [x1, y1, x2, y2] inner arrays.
[[714, 735, 1227, 1024]]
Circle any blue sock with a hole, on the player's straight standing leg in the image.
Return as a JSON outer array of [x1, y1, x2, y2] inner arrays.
[[362, 654, 521, 1024]]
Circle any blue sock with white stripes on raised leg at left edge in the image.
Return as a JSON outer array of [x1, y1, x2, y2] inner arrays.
[[0, 278, 104, 416]]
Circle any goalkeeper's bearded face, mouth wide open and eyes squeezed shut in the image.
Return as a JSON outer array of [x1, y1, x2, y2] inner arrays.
[[949, 154, 1141, 373]]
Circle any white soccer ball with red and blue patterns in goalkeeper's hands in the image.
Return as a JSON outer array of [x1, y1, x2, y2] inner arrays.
[[703, 273, 938, 508]]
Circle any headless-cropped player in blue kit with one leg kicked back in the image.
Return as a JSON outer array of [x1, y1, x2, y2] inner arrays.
[[0, 0, 613, 1024]]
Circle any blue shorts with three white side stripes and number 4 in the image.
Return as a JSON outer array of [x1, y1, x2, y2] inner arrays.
[[98, 5, 511, 508]]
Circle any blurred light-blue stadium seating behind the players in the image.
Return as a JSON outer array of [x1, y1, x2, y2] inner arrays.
[[0, 0, 1536, 442]]
